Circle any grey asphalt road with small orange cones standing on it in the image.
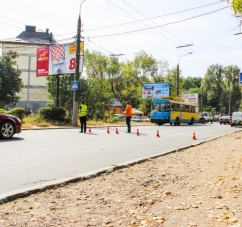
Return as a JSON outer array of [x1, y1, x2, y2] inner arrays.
[[0, 123, 242, 198]]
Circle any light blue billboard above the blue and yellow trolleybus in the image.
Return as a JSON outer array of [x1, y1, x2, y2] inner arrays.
[[142, 83, 170, 99]]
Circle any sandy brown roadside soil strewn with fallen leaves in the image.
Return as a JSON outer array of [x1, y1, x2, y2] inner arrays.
[[0, 131, 242, 227]]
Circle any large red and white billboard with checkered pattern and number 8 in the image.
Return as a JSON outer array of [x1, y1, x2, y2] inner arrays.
[[36, 42, 84, 76]]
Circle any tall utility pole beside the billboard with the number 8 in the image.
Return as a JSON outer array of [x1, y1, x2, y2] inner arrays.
[[72, 15, 81, 127]]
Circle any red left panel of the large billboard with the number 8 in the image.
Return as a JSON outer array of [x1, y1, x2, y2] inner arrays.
[[36, 47, 49, 76]]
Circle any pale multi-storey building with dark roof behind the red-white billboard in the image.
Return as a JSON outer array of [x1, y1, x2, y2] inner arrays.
[[0, 25, 57, 112]]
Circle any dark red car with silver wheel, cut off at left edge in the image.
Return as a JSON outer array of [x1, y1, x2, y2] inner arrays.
[[0, 113, 22, 139]]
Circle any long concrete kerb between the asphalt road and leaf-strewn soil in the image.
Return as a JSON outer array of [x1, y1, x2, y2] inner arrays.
[[0, 132, 236, 204]]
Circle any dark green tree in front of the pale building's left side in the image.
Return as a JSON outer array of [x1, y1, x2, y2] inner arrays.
[[0, 51, 23, 108]]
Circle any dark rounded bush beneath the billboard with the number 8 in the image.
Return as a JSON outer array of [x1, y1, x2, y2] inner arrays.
[[38, 107, 66, 121]]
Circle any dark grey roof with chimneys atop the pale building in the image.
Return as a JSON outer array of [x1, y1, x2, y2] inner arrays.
[[1, 25, 57, 44]]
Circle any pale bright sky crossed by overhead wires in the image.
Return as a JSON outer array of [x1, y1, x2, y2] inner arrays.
[[0, 0, 242, 78]]
